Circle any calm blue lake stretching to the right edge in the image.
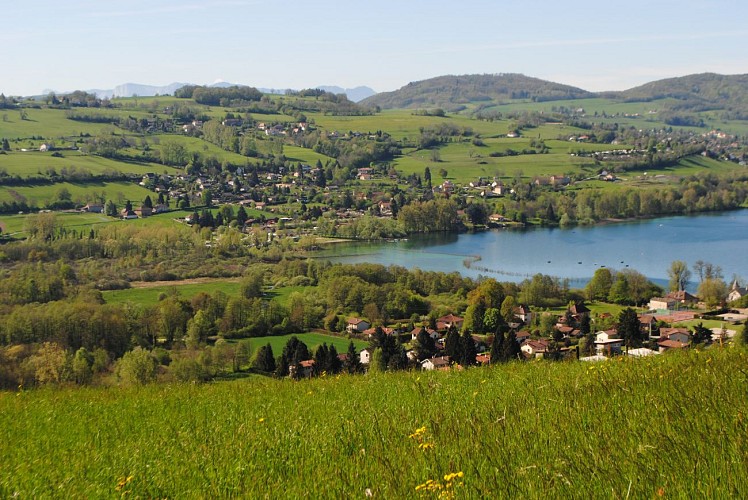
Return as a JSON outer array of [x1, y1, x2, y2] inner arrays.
[[320, 209, 748, 288]]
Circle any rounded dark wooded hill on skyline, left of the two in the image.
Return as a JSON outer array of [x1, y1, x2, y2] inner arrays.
[[360, 73, 594, 110]]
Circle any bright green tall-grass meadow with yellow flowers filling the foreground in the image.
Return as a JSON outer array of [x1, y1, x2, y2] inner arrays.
[[0, 348, 748, 498]]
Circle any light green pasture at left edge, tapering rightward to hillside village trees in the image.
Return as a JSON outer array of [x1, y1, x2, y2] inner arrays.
[[0, 150, 169, 177]]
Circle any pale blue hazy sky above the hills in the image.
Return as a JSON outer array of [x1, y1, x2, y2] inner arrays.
[[0, 0, 748, 95]]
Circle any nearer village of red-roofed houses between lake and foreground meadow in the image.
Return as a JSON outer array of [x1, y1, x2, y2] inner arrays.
[[282, 282, 748, 378]]
